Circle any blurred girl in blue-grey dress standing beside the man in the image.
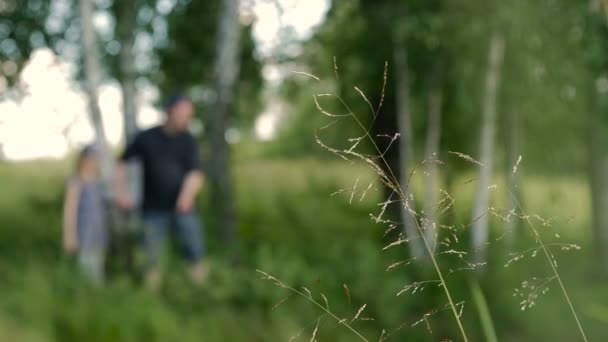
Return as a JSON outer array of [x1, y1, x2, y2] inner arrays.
[[63, 146, 108, 283]]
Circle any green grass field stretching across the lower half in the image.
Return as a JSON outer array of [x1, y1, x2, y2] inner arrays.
[[0, 158, 608, 341]]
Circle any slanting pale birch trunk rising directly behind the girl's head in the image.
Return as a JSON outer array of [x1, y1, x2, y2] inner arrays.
[[80, 0, 112, 197]]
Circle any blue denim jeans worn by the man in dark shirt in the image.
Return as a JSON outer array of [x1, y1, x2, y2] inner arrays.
[[142, 210, 204, 269]]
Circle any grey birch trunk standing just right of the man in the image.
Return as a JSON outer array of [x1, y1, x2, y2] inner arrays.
[[209, 0, 241, 242]]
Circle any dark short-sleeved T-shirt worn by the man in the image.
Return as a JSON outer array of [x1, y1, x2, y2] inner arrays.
[[120, 126, 201, 211]]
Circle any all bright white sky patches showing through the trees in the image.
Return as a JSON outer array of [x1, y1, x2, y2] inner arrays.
[[0, 0, 328, 160]]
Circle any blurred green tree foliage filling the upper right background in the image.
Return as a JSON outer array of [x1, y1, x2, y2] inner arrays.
[[277, 0, 606, 180]]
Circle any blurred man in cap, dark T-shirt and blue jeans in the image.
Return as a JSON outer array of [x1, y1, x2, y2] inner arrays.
[[116, 96, 207, 289]]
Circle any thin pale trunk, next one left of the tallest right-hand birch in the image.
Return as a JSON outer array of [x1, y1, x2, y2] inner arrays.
[[423, 61, 443, 255]]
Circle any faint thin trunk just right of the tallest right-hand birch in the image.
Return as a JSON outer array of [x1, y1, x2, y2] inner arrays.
[[505, 110, 522, 249]]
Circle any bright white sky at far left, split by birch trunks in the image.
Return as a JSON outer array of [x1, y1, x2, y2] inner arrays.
[[0, 49, 161, 160]]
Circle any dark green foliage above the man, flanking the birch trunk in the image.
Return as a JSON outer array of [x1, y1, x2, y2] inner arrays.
[[152, 0, 263, 128]]
